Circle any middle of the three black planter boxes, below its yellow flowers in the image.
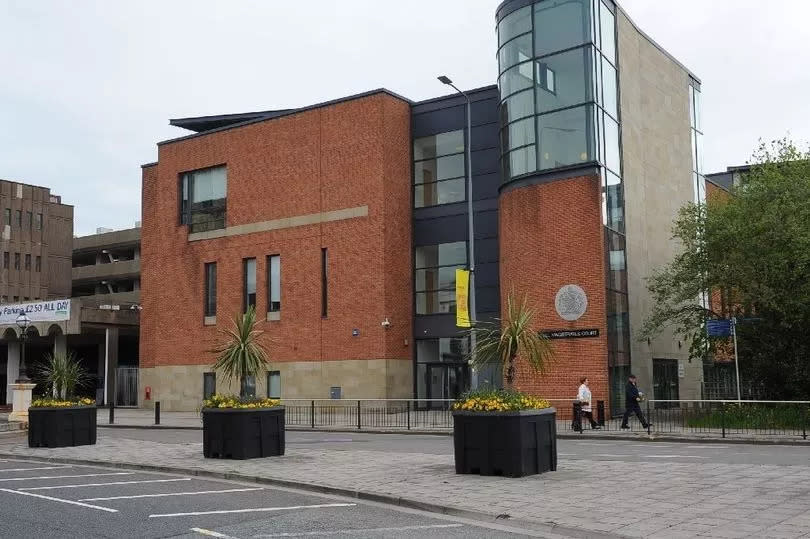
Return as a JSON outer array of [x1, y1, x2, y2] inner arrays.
[[202, 406, 284, 459]]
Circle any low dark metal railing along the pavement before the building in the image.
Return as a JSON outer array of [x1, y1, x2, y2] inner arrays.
[[282, 399, 810, 440]]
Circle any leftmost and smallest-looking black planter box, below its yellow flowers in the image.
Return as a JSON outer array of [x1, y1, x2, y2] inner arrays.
[[28, 406, 96, 447]]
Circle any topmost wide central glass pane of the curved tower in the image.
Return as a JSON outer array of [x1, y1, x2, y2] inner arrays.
[[534, 0, 591, 56]]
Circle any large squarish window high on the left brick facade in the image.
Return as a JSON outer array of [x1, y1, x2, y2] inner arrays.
[[180, 166, 228, 233]]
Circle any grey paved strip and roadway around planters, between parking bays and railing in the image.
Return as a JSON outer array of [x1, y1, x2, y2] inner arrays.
[[0, 429, 810, 539]]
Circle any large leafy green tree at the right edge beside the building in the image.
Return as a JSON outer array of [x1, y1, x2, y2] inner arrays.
[[642, 139, 810, 399]]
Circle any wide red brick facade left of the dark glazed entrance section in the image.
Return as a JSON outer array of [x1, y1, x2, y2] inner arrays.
[[140, 93, 413, 376]]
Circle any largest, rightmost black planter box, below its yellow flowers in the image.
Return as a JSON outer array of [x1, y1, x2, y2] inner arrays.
[[453, 408, 557, 477]]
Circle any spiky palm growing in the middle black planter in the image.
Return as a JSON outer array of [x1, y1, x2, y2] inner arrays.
[[213, 307, 269, 396]]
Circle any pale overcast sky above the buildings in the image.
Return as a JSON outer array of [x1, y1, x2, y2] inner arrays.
[[0, 0, 810, 235]]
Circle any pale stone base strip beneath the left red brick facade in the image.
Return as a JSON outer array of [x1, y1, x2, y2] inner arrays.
[[138, 359, 413, 412]]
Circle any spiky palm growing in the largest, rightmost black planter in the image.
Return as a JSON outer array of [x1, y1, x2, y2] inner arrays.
[[470, 294, 554, 389]]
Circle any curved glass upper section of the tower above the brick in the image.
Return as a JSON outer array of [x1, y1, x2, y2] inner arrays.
[[497, 0, 623, 184]]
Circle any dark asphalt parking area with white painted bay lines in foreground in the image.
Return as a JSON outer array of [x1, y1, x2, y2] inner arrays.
[[0, 459, 548, 539]]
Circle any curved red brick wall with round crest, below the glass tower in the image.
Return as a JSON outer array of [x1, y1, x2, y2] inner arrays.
[[499, 176, 610, 409]]
